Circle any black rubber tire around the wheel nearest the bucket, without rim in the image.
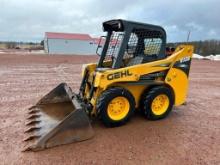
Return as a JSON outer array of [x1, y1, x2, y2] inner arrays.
[[96, 87, 135, 127]]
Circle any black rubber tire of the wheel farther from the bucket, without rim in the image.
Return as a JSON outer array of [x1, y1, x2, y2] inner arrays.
[[142, 86, 174, 120]]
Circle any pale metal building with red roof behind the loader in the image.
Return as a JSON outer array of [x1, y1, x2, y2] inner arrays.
[[44, 32, 97, 55]]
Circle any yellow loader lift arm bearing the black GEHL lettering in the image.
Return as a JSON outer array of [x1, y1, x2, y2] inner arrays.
[[94, 45, 193, 89]]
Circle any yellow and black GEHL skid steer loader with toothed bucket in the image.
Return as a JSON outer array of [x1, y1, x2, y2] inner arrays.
[[25, 19, 193, 151]]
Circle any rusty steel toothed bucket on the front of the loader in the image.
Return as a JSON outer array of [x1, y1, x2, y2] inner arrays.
[[24, 83, 94, 151]]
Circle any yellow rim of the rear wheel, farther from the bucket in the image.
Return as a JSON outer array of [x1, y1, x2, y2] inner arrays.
[[151, 94, 170, 115]]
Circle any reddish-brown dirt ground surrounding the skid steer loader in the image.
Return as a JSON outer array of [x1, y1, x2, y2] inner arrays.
[[0, 54, 220, 165]]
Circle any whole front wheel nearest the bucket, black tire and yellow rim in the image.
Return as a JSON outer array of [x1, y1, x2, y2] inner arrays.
[[96, 87, 135, 127]]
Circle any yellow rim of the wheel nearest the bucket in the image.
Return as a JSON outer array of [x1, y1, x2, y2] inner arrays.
[[107, 96, 130, 121]]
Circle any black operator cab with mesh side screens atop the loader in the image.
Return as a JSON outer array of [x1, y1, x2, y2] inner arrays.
[[97, 19, 166, 69]]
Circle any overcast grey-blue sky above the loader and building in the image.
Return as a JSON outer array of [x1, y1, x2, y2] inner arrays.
[[0, 0, 220, 41]]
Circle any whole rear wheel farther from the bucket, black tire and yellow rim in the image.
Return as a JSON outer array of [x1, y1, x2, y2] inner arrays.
[[143, 86, 174, 120]]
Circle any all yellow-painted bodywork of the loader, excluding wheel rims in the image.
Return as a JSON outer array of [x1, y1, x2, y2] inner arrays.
[[83, 45, 193, 114]]
